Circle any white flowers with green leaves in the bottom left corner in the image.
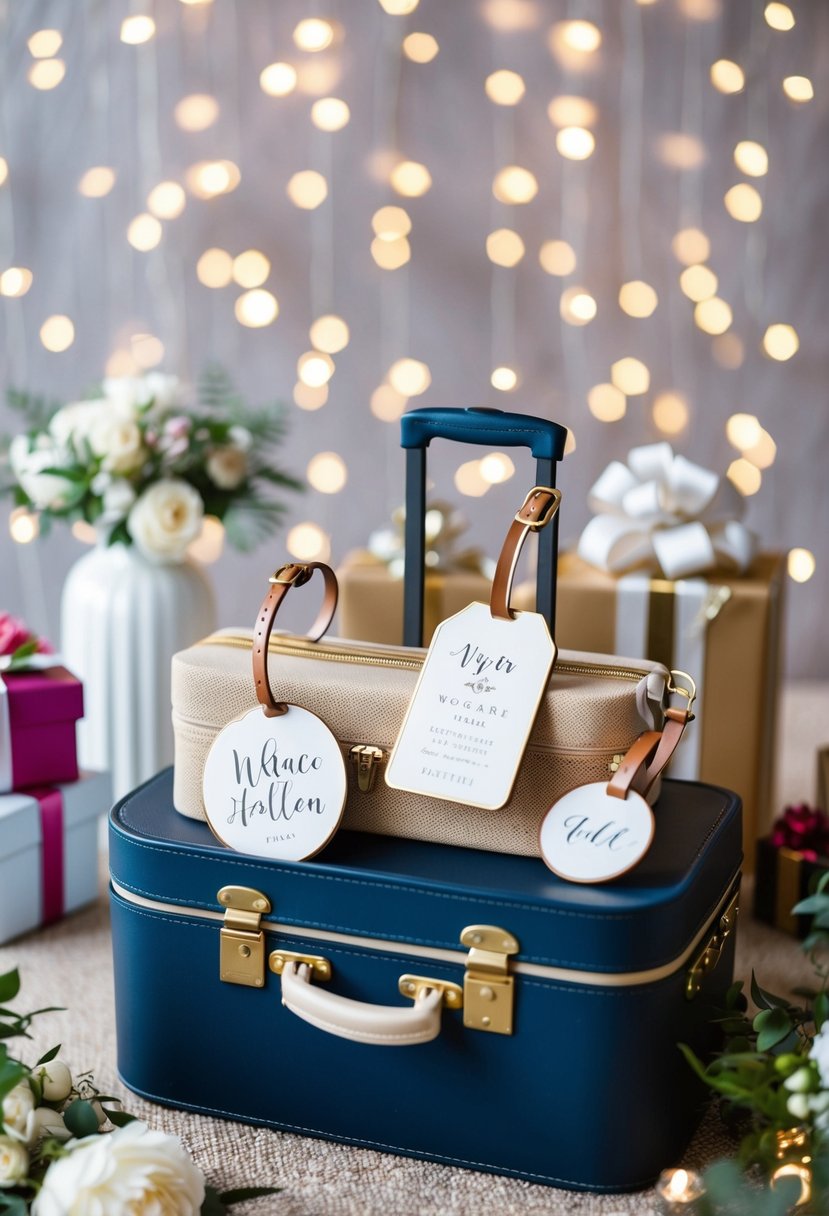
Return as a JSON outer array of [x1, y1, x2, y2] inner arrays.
[[0, 972, 277, 1216]]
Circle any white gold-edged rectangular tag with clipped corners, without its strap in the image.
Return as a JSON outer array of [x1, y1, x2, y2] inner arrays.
[[385, 603, 556, 811]]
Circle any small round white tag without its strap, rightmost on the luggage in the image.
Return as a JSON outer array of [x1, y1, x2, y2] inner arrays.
[[540, 781, 654, 883]]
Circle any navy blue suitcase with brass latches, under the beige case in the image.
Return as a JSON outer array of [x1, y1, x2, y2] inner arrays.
[[111, 772, 740, 1190]]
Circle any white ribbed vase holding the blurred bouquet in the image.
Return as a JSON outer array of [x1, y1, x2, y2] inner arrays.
[[61, 541, 215, 798]]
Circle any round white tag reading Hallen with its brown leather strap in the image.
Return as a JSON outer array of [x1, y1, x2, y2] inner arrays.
[[202, 562, 346, 861]]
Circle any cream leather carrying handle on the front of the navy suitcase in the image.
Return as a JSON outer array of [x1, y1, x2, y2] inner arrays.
[[282, 962, 442, 1047]]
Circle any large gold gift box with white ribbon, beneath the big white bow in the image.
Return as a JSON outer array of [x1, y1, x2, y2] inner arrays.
[[513, 553, 785, 868]]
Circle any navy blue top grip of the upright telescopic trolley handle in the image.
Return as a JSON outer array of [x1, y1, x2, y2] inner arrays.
[[400, 406, 568, 461]]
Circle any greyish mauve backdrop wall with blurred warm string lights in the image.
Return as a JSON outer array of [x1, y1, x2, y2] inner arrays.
[[0, 0, 829, 675]]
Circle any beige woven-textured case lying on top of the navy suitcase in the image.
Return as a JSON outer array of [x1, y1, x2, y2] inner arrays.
[[173, 630, 667, 856]]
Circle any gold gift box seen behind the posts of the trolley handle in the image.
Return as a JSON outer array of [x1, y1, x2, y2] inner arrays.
[[337, 550, 490, 646]]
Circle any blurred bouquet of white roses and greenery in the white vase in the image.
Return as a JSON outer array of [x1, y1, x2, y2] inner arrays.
[[0, 370, 301, 563]]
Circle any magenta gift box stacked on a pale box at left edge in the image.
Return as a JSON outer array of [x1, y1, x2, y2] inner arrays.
[[0, 666, 84, 793]]
